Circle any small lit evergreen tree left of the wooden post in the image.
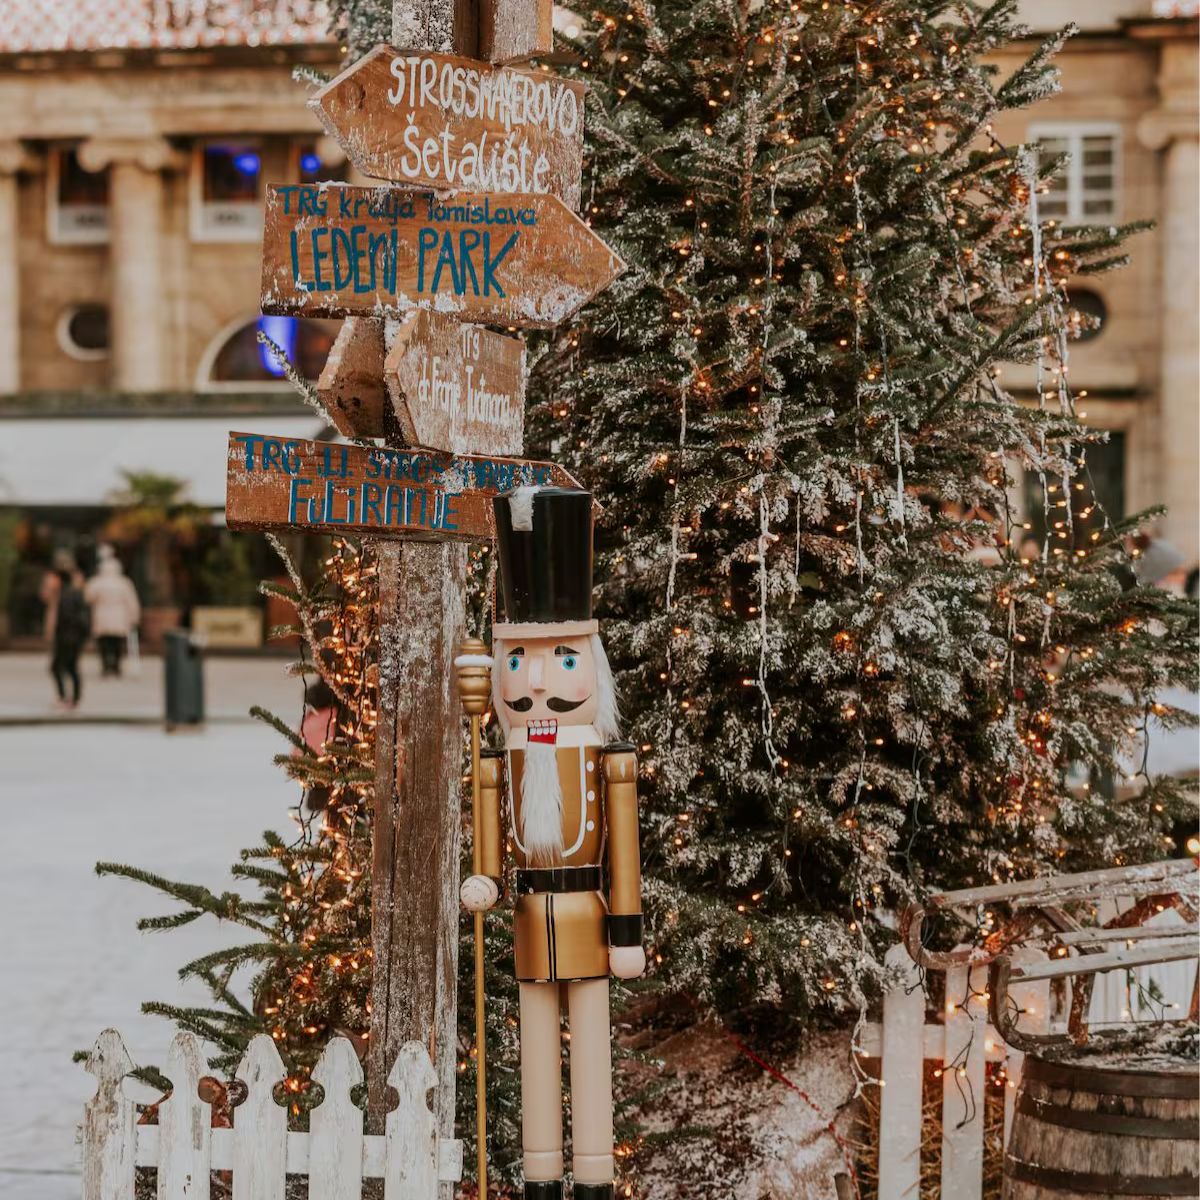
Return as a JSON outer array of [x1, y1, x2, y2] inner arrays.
[[96, 541, 378, 1102]]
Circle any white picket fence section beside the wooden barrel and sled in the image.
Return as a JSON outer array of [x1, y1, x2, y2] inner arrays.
[[859, 946, 1050, 1200]]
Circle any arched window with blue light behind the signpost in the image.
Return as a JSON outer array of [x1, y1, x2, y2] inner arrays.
[[197, 317, 338, 391]]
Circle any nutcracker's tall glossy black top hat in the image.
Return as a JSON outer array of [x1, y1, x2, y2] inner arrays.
[[492, 487, 596, 637]]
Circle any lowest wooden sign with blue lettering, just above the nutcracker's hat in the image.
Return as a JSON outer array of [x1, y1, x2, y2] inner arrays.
[[226, 433, 580, 541]]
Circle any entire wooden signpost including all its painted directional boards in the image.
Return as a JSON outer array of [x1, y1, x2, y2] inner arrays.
[[227, 0, 624, 1200]]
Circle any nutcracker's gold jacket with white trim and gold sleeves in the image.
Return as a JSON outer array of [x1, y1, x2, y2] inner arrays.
[[476, 725, 642, 983]]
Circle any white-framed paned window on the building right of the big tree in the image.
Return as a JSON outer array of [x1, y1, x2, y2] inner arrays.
[[1030, 125, 1121, 224]]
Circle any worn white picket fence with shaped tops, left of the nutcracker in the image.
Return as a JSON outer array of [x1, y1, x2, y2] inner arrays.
[[83, 1030, 462, 1200]]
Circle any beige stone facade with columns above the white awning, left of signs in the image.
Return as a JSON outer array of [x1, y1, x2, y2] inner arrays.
[[0, 0, 341, 404]]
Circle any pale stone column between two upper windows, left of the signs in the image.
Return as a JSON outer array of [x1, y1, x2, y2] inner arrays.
[[79, 138, 176, 391]]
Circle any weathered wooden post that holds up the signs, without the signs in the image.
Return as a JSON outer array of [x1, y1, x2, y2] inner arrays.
[[367, 0, 467, 1176]]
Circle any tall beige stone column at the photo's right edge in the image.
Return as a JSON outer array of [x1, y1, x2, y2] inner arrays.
[[1138, 38, 1200, 566]]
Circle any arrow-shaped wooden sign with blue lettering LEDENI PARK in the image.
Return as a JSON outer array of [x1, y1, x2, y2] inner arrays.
[[263, 184, 625, 328]]
